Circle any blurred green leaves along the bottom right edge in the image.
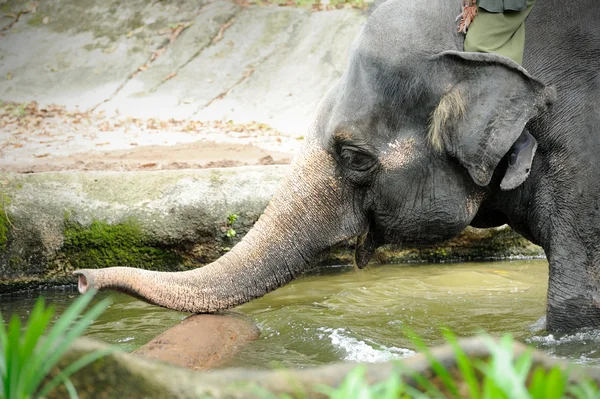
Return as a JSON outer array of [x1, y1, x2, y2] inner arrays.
[[321, 331, 600, 399]]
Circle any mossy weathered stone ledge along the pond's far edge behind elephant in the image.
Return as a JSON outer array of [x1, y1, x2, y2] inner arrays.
[[0, 165, 543, 294]]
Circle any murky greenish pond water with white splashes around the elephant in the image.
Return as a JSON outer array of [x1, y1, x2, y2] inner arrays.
[[0, 260, 600, 367]]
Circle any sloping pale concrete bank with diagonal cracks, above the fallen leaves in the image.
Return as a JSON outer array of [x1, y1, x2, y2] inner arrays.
[[0, 0, 364, 134]]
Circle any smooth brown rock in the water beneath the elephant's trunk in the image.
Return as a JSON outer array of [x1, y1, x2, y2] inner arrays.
[[133, 312, 260, 370]]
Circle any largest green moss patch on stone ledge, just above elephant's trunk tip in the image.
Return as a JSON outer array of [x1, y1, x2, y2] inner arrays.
[[61, 220, 182, 271]]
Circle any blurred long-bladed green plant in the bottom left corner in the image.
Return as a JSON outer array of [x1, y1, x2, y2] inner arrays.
[[0, 291, 114, 399]]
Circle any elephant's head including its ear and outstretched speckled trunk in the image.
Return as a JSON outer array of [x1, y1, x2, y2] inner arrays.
[[75, 0, 551, 312]]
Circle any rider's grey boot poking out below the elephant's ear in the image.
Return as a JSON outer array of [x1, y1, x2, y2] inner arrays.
[[500, 130, 537, 191]]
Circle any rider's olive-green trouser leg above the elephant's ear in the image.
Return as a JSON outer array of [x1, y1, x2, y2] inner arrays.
[[464, 0, 535, 64]]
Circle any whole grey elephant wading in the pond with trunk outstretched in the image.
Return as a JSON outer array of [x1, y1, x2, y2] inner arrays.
[[74, 0, 600, 331]]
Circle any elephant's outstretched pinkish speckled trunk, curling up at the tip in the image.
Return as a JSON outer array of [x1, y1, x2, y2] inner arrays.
[[75, 145, 366, 313]]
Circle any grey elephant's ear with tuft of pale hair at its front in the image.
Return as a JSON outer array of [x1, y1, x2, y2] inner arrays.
[[430, 51, 556, 186]]
